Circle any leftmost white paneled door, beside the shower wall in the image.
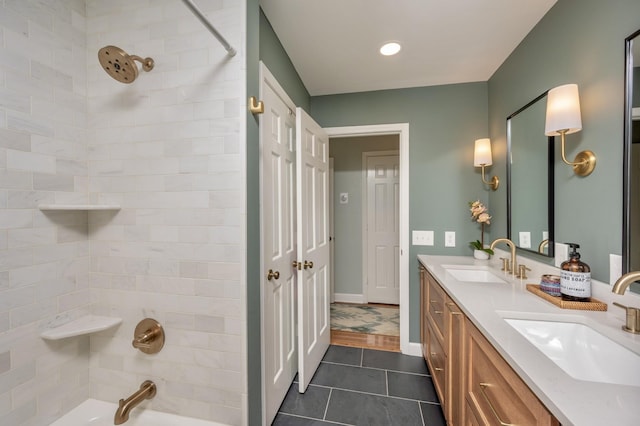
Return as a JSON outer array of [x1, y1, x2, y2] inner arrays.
[[260, 72, 298, 424]]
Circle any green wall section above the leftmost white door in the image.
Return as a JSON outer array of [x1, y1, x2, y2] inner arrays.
[[260, 9, 310, 112]]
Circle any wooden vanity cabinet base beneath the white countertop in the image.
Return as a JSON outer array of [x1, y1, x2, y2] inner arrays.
[[420, 266, 559, 426]]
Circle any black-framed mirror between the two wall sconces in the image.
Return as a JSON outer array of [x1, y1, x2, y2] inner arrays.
[[507, 92, 554, 257]]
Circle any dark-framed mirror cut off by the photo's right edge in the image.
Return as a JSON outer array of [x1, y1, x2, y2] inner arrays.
[[622, 30, 640, 286]]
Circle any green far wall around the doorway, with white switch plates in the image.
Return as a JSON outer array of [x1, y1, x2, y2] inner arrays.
[[311, 83, 490, 342]]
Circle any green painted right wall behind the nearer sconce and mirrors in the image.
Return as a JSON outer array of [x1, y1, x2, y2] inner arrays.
[[489, 0, 640, 282]]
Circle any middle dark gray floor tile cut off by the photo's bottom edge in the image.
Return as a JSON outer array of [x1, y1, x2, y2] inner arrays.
[[325, 389, 422, 426]]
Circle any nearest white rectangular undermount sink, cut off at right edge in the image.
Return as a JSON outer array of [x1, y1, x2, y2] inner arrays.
[[505, 318, 640, 386]]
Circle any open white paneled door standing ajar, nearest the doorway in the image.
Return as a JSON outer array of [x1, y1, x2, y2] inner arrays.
[[296, 108, 331, 393]]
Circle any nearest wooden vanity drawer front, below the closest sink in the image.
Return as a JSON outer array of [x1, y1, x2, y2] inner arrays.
[[466, 320, 558, 425]]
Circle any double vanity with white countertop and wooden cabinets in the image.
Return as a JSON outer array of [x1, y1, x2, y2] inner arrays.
[[418, 255, 640, 426]]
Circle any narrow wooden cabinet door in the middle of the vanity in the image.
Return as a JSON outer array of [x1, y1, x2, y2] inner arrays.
[[445, 296, 465, 425]]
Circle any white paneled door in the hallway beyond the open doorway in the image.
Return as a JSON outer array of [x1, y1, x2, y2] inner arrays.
[[366, 154, 400, 305]]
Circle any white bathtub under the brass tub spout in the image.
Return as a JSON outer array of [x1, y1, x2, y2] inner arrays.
[[50, 399, 230, 426]]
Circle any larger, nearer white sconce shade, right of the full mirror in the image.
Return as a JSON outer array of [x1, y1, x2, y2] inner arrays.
[[544, 84, 582, 136]]
